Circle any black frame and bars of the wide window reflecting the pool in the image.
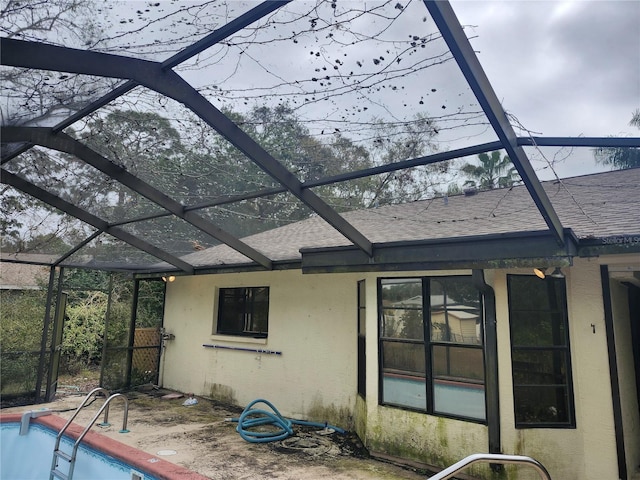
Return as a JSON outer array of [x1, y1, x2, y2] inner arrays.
[[377, 275, 488, 425]]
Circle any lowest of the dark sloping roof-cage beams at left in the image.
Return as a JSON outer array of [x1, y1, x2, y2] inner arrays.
[[0, 168, 194, 274]]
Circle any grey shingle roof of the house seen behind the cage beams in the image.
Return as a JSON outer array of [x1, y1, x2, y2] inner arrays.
[[183, 168, 640, 266]]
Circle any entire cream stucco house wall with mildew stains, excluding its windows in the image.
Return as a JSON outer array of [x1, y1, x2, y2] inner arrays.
[[163, 258, 626, 480]]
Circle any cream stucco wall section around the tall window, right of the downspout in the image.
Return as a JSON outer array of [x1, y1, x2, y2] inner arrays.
[[494, 258, 618, 480]]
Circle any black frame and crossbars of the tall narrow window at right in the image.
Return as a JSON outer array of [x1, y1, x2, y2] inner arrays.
[[507, 274, 576, 429]]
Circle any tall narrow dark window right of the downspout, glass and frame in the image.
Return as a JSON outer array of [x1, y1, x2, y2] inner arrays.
[[507, 275, 575, 428]]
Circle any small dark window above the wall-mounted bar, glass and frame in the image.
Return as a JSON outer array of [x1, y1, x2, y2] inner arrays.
[[216, 287, 269, 338]]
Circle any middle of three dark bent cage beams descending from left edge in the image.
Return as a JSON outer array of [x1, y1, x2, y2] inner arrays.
[[0, 127, 272, 269]]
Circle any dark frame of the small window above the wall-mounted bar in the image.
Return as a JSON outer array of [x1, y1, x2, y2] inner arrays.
[[213, 286, 270, 339]]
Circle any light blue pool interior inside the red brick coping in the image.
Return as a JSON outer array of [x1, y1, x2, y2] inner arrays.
[[0, 423, 156, 480]]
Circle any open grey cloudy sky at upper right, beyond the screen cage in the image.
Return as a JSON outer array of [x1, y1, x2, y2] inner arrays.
[[452, 0, 640, 173]]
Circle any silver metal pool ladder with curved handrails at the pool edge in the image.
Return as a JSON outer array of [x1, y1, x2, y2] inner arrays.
[[49, 387, 129, 480]]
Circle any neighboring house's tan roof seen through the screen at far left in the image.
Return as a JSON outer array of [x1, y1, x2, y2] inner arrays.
[[0, 253, 51, 290]]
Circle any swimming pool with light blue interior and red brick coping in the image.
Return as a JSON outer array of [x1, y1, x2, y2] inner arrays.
[[0, 414, 206, 480]]
